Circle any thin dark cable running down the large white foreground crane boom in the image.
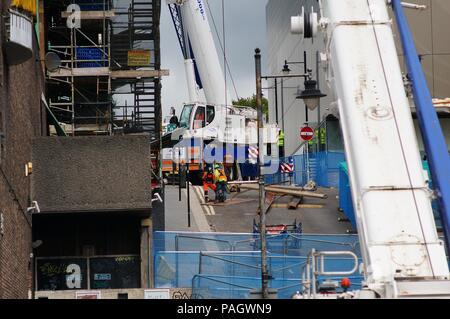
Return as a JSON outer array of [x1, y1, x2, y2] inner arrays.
[[366, 0, 436, 277]]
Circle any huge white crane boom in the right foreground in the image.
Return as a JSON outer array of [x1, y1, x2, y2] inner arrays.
[[292, 0, 450, 298]]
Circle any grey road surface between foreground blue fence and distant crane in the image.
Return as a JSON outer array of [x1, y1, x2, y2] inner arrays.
[[166, 186, 353, 234]]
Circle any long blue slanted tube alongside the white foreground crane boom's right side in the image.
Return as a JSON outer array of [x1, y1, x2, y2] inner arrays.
[[391, 0, 450, 248]]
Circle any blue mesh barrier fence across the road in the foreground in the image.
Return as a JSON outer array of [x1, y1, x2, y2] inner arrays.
[[153, 232, 362, 298]]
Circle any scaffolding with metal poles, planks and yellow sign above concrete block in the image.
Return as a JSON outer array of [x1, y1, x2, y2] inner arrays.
[[44, 0, 163, 141]]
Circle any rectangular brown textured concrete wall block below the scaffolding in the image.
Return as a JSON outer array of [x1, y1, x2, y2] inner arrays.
[[31, 135, 151, 212]]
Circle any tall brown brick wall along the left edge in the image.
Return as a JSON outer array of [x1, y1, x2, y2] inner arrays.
[[0, 0, 45, 299]]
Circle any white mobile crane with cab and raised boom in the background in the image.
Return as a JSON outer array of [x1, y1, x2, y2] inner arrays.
[[163, 0, 278, 180]]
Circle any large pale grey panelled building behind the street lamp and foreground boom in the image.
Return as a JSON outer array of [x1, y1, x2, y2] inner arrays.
[[263, 0, 450, 156]]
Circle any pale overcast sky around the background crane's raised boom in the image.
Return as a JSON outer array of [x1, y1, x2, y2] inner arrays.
[[161, 0, 267, 116]]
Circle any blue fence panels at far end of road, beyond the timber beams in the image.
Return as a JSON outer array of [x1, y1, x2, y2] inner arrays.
[[265, 152, 345, 188]]
